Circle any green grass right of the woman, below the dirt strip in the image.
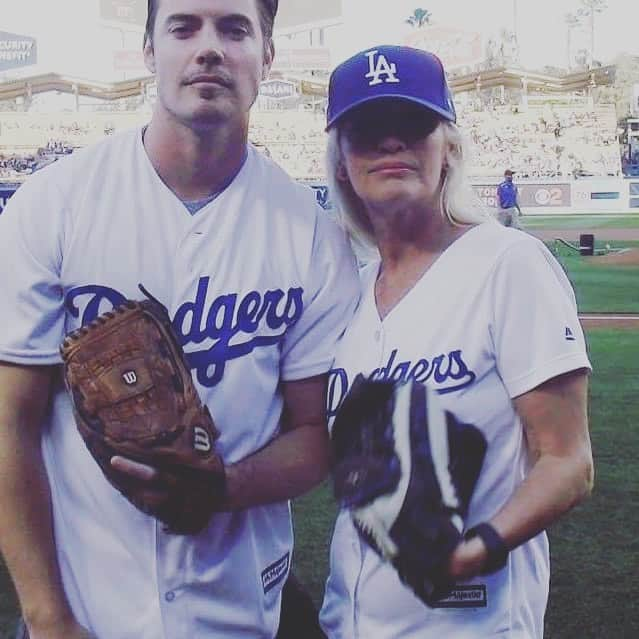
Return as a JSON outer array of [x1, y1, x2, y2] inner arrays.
[[547, 329, 639, 639]]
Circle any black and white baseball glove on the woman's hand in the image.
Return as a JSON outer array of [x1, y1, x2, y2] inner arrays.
[[331, 375, 486, 605]]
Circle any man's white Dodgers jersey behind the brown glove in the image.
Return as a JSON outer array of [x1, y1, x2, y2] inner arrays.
[[0, 130, 359, 639]]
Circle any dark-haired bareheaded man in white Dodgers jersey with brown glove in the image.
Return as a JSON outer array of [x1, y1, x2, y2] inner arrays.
[[0, 0, 358, 639]]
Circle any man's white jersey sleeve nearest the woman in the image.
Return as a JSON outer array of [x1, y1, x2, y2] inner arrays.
[[281, 210, 360, 381]]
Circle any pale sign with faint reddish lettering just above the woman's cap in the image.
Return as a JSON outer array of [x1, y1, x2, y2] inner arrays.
[[404, 26, 483, 69]]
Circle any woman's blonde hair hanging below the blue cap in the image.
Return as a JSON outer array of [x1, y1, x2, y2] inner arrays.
[[326, 120, 488, 249]]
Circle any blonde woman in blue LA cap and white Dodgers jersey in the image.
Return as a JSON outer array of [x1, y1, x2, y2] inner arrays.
[[321, 46, 593, 639]]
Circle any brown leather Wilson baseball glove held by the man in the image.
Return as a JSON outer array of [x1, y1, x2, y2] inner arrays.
[[60, 299, 225, 534]]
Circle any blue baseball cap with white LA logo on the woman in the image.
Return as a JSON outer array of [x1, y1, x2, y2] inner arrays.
[[326, 45, 457, 130]]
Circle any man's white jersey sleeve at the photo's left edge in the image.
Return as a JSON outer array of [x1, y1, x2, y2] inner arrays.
[[0, 169, 64, 365]]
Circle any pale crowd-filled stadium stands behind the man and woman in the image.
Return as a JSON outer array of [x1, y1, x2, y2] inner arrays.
[[0, 99, 622, 180]]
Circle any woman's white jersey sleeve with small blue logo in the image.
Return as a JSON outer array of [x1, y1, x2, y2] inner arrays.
[[491, 238, 591, 398]]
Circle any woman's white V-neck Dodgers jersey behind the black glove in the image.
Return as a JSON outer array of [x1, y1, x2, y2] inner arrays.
[[321, 221, 590, 639]]
